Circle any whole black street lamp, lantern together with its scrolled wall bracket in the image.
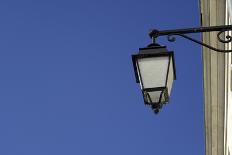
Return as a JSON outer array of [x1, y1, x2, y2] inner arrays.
[[132, 25, 232, 114]]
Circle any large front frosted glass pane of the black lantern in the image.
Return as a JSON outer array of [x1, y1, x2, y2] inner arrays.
[[137, 56, 169, 89]]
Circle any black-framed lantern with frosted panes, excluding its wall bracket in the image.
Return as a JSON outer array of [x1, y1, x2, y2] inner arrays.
[[132, 44, 176, 113]]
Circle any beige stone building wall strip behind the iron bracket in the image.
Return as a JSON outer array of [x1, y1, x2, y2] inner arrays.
[[200, 0, 227, 155]]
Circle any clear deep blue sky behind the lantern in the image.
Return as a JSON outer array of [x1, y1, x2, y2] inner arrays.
[[0, 0, 204, 155]]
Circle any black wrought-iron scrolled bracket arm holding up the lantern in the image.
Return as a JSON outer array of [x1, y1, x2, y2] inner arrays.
[[149, 25, 232, 53]]
